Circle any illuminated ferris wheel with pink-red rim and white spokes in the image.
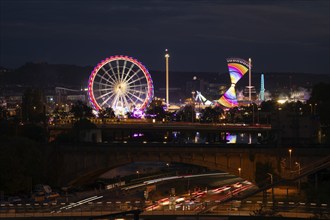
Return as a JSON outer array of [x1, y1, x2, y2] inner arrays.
[[88, 55, 154, 115]]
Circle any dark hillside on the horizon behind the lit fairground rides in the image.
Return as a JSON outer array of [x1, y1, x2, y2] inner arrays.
[[0, 63, 330, 96]]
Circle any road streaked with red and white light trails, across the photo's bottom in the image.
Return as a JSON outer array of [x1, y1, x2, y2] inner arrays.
[[0, 173, 330, 218]]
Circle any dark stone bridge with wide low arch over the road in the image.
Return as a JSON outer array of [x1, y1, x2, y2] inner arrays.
[[49, 142, 330, 186]]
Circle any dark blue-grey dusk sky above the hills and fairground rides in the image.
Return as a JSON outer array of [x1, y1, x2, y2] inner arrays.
[[0, 0, 330, 74]]
